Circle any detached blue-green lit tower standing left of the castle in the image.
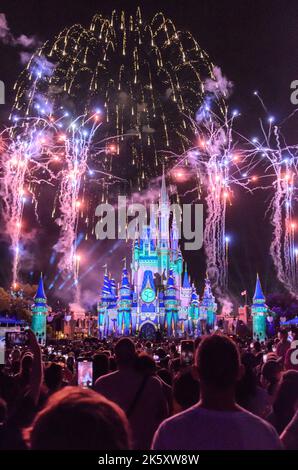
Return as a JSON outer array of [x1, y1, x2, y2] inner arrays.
[[31, 274, 48, 345]]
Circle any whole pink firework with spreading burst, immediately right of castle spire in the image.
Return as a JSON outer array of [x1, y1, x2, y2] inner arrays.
[[173, 105, 251, 295]]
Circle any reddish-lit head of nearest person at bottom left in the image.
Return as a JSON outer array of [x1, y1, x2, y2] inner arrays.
[[25, 387, 130, 450]]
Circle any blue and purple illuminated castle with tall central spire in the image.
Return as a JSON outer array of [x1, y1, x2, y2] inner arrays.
[[98, 175, 217, 338]]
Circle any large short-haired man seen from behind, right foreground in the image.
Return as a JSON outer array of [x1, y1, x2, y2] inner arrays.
[[153, 335, 281, 450]]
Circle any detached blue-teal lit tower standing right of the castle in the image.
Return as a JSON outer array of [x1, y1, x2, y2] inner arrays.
[[251, 274, 268, 341]]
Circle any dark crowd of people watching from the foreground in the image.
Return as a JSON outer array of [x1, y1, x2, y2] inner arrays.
[[0, 328, 298, 450]]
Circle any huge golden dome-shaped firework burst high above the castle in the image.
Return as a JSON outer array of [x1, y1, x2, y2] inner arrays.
[[13, 9, 224, 191]]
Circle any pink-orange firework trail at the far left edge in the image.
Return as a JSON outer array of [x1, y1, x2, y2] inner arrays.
[[1, 118, 54, 287]]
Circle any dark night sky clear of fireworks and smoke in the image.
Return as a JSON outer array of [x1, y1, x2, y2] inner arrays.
[[0, 0, 298, 306]]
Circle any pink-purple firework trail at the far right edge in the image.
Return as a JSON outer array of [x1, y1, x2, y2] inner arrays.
[[248, 109, 298, 296]]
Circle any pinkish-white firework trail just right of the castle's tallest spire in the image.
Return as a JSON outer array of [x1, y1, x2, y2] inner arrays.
[[190, 112, 240, 291]]
